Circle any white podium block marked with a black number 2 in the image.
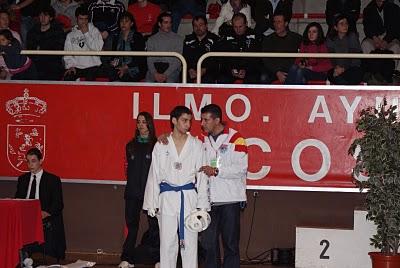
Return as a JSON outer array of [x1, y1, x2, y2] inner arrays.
[[296, 210, 378, 268]]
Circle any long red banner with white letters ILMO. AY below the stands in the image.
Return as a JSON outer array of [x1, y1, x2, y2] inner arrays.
[[0, 83, 399, 190]]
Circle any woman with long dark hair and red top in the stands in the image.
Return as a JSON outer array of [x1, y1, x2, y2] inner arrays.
[[285, 22, 332, 85]]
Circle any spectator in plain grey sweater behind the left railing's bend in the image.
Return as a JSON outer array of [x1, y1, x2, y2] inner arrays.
[[146, 12, 183, 83]]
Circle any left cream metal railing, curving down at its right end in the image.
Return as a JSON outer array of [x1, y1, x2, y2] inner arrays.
[[21, 50, 187, 84]]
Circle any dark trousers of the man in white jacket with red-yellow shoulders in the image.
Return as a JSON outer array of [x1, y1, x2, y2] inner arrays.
[[201, 202, 240, 268]]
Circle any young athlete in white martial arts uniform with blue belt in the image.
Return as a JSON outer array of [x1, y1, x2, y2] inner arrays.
[[143, 106, 210, 268]]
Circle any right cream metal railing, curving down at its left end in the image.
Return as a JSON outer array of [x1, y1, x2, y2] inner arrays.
[[196, 52, 400, 84]]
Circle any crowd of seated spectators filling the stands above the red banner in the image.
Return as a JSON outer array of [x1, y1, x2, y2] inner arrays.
[[0, 0, 400, 84]]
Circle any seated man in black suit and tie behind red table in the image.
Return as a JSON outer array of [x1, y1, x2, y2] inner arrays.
[[15, 148, 66, 260]]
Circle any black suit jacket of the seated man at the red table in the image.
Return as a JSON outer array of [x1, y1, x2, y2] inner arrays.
[[15, 171, 66, 259]]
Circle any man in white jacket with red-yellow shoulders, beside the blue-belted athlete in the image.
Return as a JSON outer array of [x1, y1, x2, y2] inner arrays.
[[200, 104, 248, 268]]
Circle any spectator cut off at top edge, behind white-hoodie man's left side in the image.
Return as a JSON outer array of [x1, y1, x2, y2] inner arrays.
[[52, 0, 79, 32]]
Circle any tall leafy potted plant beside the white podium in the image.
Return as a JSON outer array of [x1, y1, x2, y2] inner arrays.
[[349, 99, 400, 268]]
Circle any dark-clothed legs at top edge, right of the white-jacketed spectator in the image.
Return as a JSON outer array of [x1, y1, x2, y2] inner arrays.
[[249, 0, 293, 36]]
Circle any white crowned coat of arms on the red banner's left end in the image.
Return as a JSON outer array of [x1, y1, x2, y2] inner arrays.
[[6, 89, 47, 172]]
